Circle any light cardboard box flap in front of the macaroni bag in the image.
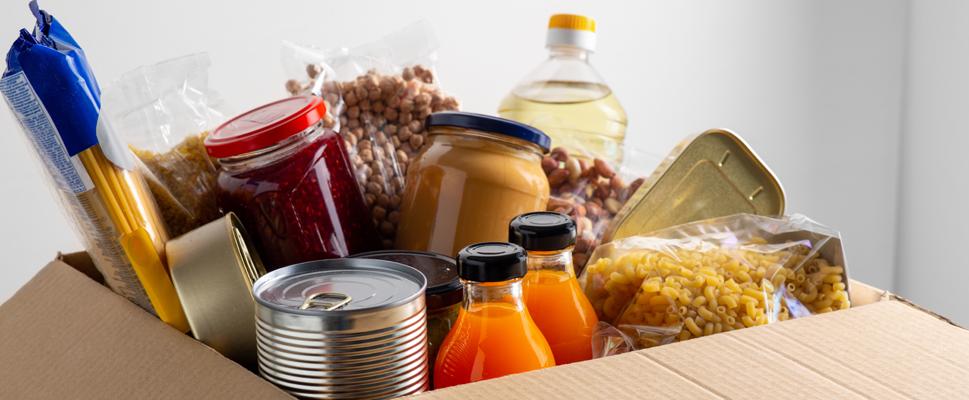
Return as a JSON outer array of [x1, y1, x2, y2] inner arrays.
[[418, 301, 969, 399]]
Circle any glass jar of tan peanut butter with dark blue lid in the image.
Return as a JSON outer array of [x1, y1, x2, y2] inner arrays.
[[396, 112, 550, 255]]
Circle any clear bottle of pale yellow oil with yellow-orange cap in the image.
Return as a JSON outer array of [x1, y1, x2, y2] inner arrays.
[[498, 14, 626, 164]]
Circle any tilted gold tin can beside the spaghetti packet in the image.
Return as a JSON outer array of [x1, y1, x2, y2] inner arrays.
[[166, 213, 266, 367]]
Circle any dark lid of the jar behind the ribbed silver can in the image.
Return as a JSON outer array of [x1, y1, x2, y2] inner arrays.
[[352, 250, 464, 309]]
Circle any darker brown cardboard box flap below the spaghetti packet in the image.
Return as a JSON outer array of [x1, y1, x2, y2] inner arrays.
[[0, 261, 290, 399]]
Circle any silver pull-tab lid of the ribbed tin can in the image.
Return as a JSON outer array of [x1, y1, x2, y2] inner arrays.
[[253, 258, 427, 314]]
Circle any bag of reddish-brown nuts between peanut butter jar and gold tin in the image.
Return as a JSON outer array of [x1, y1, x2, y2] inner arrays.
[[542, 147, 644, 274]]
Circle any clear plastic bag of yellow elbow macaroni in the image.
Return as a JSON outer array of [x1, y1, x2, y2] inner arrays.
[[579, 214, 850, 356]]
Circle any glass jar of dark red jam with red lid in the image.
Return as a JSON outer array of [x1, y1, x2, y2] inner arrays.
[[205, 96, 379, 271]]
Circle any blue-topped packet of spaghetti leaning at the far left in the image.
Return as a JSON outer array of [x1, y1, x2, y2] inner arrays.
[[0, 1, 188, 332]]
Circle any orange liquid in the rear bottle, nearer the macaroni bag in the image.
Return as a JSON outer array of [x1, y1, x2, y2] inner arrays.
[[523, 270, 599, 365]]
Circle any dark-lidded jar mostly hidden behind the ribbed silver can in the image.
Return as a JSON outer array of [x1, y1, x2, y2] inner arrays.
[[353, 250, 464, 387]]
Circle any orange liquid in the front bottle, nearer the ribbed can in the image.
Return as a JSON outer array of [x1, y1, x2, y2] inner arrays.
[[434, 304, 555, 388]]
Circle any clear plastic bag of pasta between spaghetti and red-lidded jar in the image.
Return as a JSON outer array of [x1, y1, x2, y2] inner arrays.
[[103, 53, 225, 237]]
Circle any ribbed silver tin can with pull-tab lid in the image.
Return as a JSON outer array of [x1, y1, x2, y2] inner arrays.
[[253, 258, 429, 399]]
